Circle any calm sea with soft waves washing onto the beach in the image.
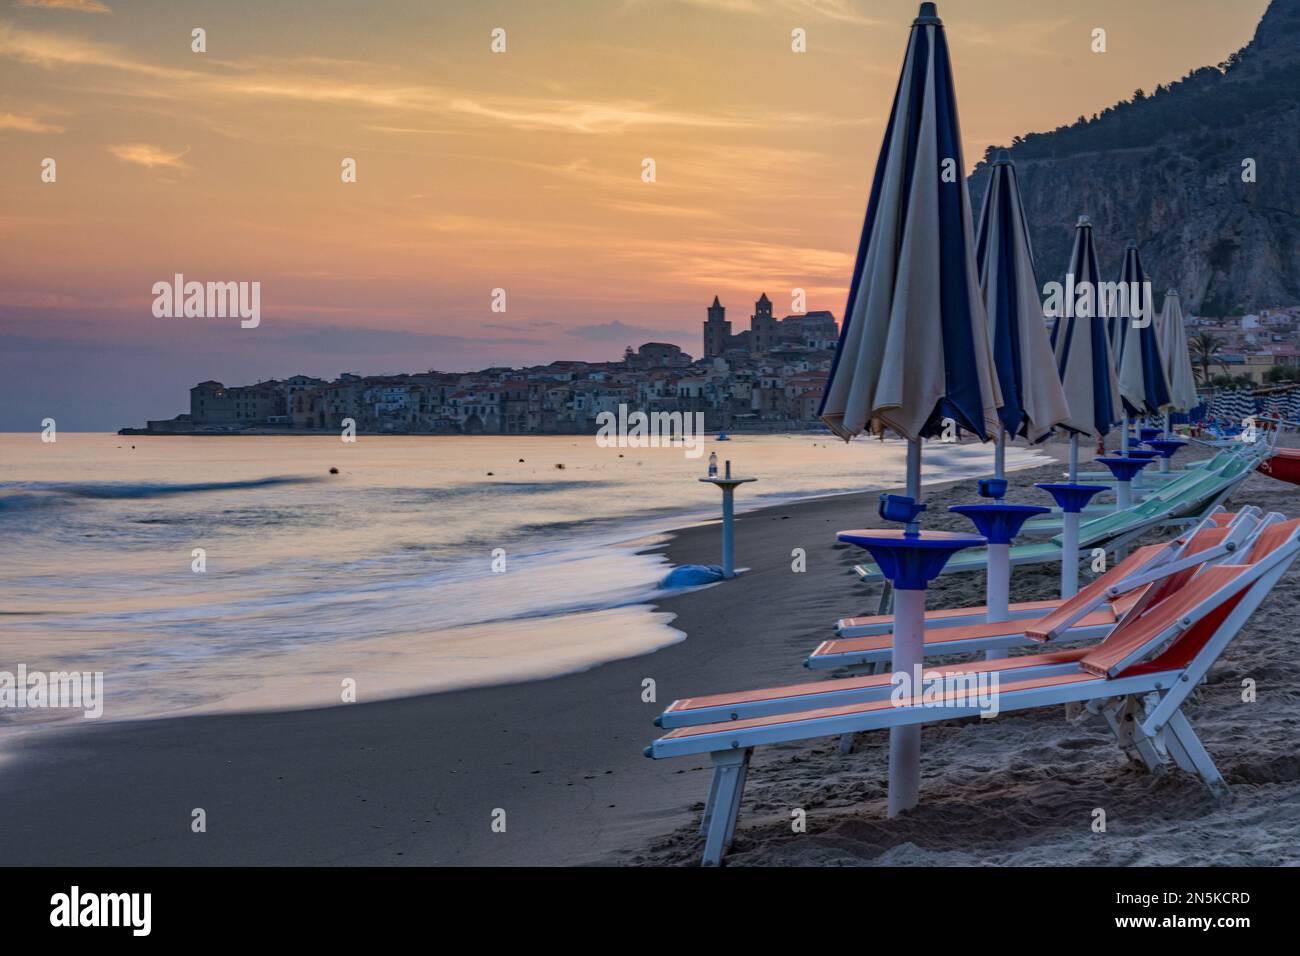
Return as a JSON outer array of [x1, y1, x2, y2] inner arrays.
[[0, 432, 1045, 732]]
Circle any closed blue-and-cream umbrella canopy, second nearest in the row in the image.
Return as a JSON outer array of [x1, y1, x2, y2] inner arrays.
[[975, 150, 1070, 442]]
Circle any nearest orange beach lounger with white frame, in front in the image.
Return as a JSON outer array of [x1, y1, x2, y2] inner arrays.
[[646, 520, 1300, 865]]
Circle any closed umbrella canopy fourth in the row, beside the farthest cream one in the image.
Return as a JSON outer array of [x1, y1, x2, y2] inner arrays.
[[1112, 242, 1169, 416]]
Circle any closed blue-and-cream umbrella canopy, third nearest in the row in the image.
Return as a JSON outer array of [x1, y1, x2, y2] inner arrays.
[[1052, 216, 1119, 437]]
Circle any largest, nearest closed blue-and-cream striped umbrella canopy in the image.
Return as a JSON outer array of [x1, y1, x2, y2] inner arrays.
[[819, 3, 1001, 441]]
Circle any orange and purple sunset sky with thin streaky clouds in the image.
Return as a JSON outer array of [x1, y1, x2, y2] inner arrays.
[[0, 0, 1268, 431]]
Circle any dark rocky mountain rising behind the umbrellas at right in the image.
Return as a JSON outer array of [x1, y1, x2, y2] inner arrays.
[[971, 0, 1300, 316]]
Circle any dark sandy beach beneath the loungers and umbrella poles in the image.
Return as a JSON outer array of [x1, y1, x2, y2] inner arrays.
[[0, 442, 1300, 865]]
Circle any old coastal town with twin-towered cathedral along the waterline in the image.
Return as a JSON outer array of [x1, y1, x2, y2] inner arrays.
[[122, 294, 1300, 434]]
